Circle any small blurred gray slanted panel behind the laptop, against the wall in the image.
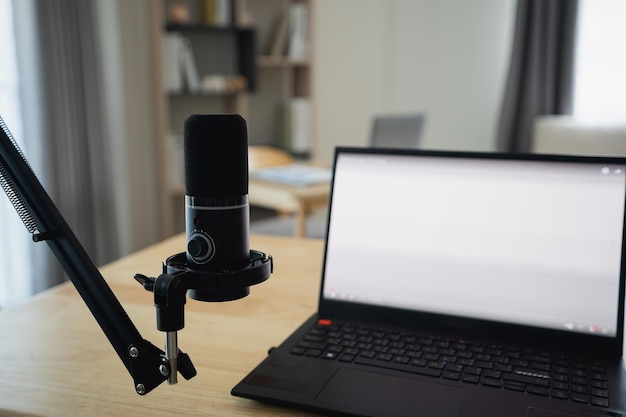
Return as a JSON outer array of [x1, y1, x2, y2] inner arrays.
[[370, 114, 424, 148]]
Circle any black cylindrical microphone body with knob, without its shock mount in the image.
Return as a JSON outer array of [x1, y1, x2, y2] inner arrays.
[[184, 114, 250, 301]]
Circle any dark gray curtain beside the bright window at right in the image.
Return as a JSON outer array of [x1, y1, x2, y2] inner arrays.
[[497, 0, 578, 152]]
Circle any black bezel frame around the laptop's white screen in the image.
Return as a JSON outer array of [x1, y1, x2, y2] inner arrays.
[[318, 147, 626, 358]]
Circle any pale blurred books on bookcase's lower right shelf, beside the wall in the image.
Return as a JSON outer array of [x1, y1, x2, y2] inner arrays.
[[279, 97, 311, 156]]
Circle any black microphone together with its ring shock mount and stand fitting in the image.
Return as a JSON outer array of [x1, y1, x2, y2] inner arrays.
[[135, 114, 274, 384]]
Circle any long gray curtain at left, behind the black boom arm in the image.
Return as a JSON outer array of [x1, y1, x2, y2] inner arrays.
[[16, 0, 120, 291]]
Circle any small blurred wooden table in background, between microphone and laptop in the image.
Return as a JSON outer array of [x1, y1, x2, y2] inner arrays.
[[248, 176, 330, 237]]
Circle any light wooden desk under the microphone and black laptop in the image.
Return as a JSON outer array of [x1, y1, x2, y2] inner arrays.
[[0, 236, 323, 417]]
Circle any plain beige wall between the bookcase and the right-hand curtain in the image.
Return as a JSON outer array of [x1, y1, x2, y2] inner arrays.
[[314, 0, 515, 161]]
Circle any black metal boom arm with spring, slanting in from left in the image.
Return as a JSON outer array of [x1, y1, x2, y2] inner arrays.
[[0, 118, 196, 395]]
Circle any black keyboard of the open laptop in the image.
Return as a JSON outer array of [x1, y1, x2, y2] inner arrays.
[[291, 319, 609, 407]]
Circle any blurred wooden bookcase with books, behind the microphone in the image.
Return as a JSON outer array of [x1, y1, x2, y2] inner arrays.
[[154, 0, 314, 233]]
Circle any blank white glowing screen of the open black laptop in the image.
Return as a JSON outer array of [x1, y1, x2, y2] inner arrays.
[[322, 149, 626, 337]]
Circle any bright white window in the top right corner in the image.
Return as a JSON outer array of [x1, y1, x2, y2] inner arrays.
[[574, 0, 626, 124]]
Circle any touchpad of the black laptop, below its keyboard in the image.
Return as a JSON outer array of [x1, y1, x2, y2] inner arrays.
[[317, 368, 465, 417]]
